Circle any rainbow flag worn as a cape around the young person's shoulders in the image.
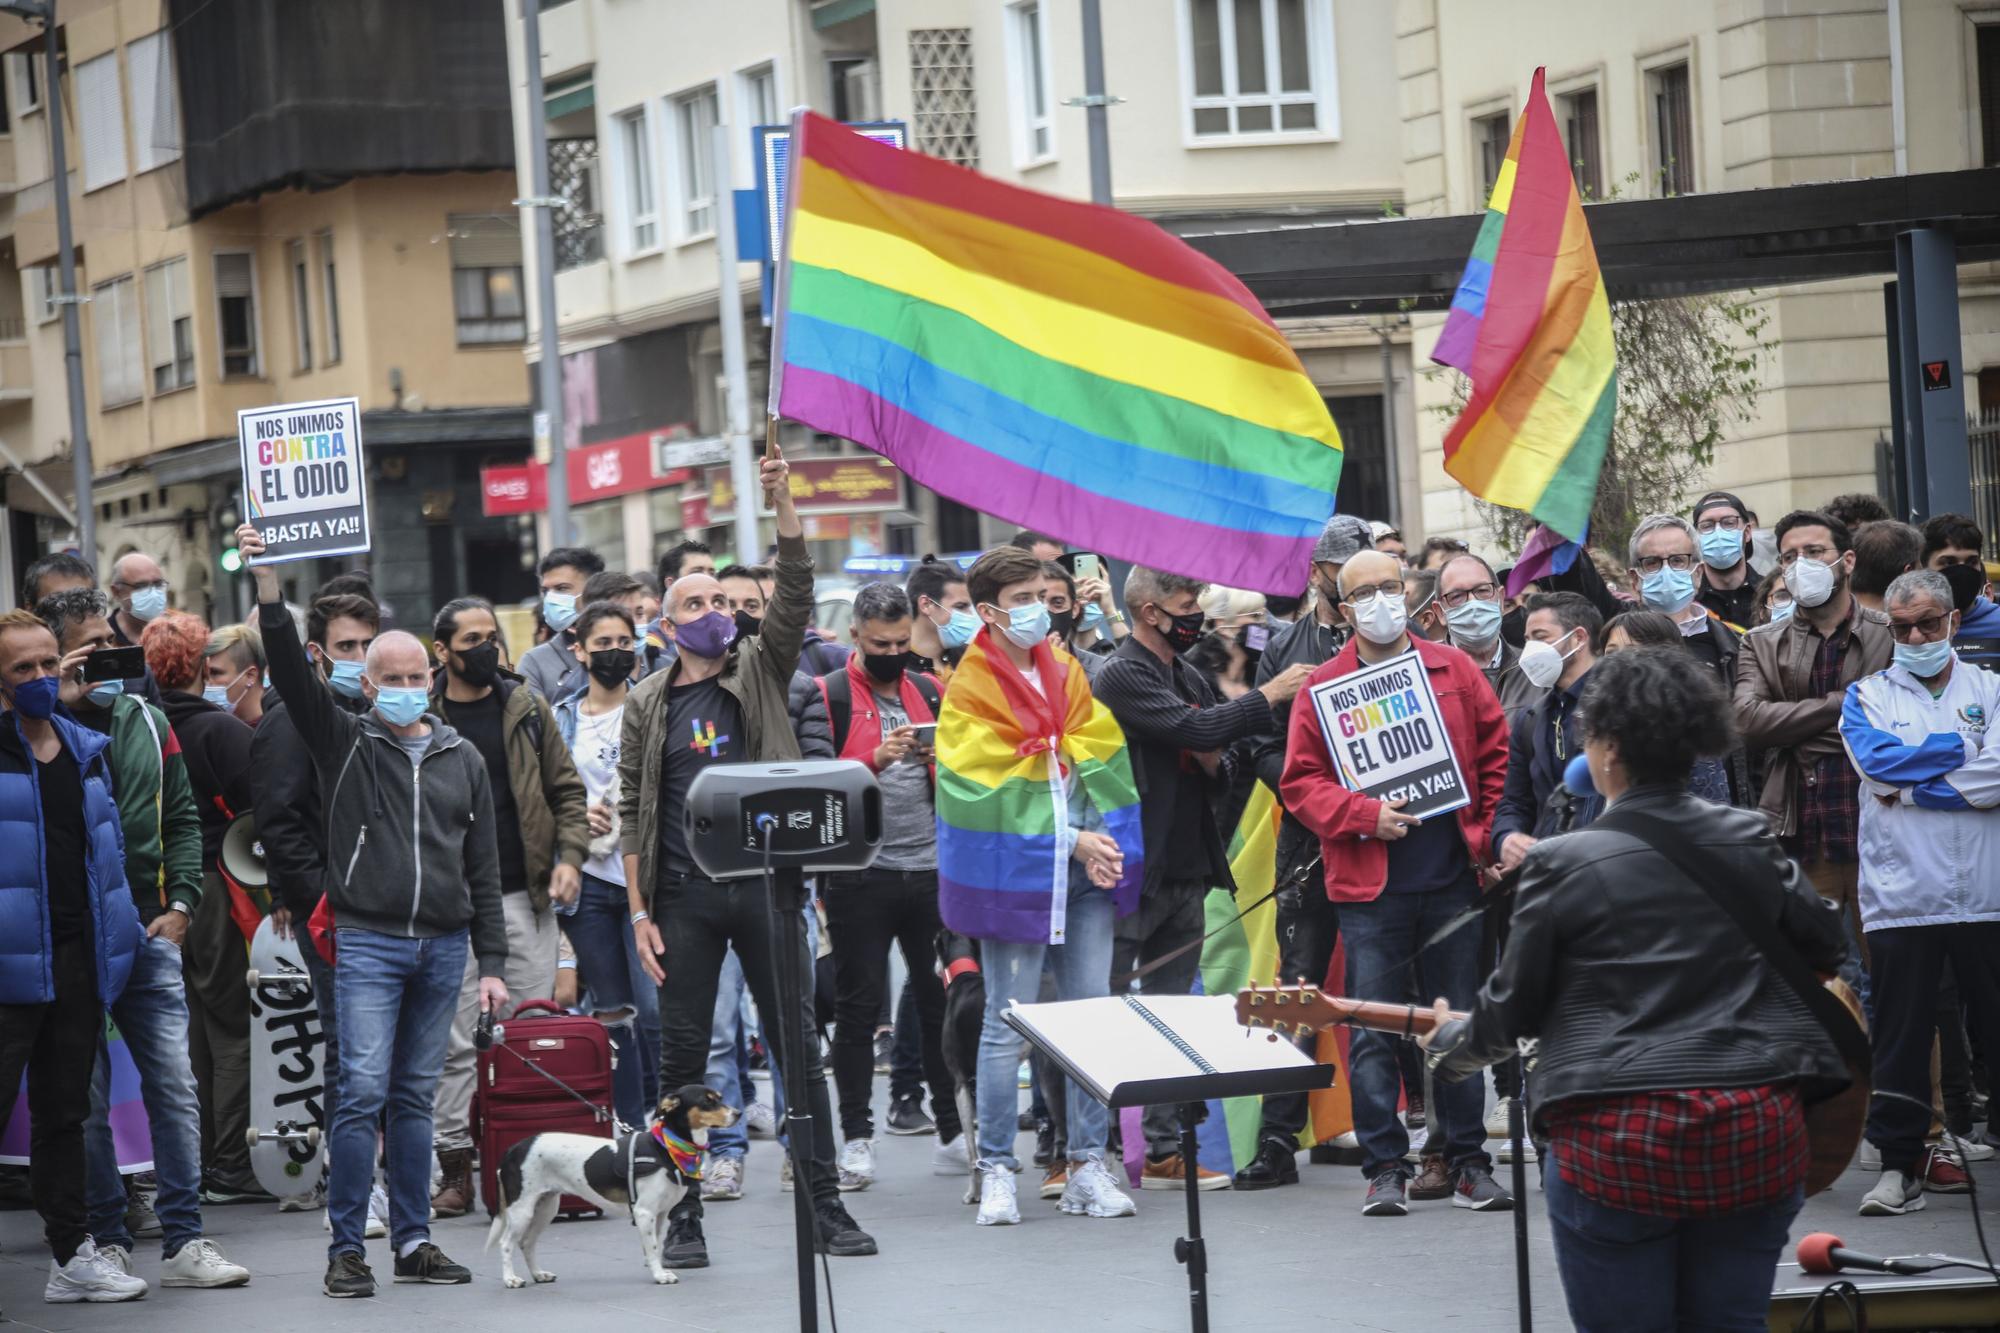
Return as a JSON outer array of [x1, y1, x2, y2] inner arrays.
[[938, 628, 1144, 945]]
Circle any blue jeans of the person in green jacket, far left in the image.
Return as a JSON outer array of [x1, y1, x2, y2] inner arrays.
[[84, 935, 202, 1257]]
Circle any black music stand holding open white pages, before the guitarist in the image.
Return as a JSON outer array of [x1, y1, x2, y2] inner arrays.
[[1004, 995, 1334, 1333]]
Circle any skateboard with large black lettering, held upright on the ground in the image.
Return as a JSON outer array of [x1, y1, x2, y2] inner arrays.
[[246, 917, 326, 1199]]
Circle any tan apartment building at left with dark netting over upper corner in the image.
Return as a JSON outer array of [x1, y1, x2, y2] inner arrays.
[[0, 0, 534, 622]]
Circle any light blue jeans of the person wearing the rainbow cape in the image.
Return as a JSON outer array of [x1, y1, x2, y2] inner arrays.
[[978, 877, 1116, 1171]]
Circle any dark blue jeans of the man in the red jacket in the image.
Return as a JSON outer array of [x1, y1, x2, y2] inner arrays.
[[1340, 875, 1492, 1179]]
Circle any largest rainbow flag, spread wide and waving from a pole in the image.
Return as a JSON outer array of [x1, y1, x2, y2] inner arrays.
[[770, 112, 1340, 594]]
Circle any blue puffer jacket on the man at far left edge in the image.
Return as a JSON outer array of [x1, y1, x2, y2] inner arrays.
[[0, 713, 144, 1005]]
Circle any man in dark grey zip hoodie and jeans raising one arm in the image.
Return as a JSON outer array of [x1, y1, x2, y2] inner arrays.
[[236, 524, 508, 1297]]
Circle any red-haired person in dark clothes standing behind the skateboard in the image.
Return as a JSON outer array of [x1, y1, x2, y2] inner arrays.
[[138, 610, 272, 1203]]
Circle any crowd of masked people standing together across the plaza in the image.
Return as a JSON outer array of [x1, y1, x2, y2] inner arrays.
[[0, 458, 2000, 1323]]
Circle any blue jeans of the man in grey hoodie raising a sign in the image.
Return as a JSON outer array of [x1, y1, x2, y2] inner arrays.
[[326, 927, 472, 1257]]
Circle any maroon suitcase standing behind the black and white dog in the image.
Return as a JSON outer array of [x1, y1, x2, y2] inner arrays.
[[472, 999, 612, 1217]]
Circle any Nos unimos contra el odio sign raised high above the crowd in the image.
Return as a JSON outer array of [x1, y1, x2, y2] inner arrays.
[[236, 398, 368, 564]]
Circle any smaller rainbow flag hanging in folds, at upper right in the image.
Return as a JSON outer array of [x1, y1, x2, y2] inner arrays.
[[1430, 70, 1618, 538]]
